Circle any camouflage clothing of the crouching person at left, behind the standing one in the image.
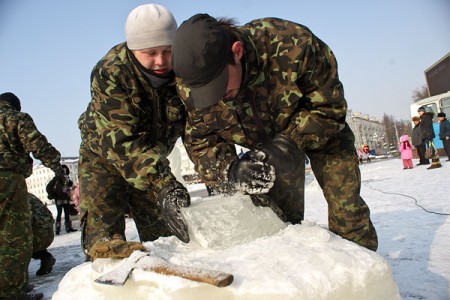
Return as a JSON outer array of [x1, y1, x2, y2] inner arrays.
[[28, 193, 55, 257]]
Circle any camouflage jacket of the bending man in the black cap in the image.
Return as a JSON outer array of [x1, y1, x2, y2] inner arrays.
[[177, 18, 347, 181]]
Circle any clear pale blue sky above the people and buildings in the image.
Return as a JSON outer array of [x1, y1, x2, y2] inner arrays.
[[0, 0, 450, 156]]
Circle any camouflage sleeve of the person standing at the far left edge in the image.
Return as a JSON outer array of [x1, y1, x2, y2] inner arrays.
[[18, 113, 61, 171]]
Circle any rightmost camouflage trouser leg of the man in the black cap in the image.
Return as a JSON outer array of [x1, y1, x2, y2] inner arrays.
[[307, 126, 378, 251]]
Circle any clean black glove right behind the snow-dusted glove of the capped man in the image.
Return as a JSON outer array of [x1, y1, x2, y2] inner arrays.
[[258, 133, 303, 173]]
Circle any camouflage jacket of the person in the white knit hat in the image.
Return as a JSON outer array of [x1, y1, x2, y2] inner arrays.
[[78, 43, 186, 190]]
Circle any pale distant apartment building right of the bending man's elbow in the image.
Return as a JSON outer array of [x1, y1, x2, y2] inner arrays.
[[346, 110, 386, 155]]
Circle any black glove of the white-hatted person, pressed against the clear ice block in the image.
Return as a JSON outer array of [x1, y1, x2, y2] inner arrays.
[[158, 181, 191, 243]]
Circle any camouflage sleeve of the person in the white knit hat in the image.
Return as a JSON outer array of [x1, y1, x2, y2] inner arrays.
[[87, 72, 175, 191]]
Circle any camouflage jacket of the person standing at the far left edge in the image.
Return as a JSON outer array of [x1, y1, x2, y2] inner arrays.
[[0, 101, 61, 177]]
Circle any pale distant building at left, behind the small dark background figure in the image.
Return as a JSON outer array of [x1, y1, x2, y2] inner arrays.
[[26, 157, 78, 204]]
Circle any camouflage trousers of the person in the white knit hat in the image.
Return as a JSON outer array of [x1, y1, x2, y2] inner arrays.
[[78, 150, 171, 253]]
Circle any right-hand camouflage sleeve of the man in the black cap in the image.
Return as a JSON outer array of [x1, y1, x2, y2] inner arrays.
[[284, 23, 347, 150]]
